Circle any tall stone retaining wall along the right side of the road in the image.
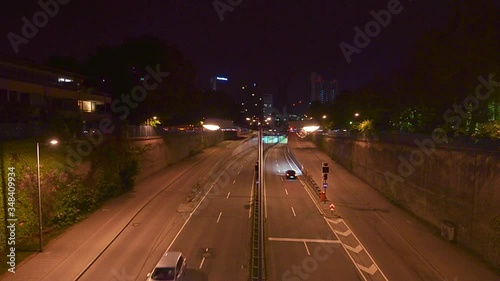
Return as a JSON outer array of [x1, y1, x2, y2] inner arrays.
[[313, 136, 500, 270]]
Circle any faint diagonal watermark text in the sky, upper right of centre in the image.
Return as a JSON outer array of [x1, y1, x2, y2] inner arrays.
[[339, 0, 411, 63]]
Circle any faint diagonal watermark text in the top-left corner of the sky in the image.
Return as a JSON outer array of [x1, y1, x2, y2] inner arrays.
[[7, 0, 71, 54]]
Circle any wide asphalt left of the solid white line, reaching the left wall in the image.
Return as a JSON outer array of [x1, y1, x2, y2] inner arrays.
[[1, 139, 239, 281]]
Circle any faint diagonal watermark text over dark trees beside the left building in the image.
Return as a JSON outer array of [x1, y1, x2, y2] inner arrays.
[[58, 64, 170, 171]]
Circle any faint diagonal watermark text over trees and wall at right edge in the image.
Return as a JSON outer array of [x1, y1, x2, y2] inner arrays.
[[384, 74, 500, 191]]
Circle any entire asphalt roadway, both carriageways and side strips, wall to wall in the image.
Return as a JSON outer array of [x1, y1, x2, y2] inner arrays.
[[1, 136, 500, 281]]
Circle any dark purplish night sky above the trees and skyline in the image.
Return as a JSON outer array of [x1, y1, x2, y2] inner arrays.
[[0, 0, 492, 111]]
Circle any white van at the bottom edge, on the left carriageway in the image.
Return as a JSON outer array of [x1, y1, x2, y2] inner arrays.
[[147, 251, 187, 281]]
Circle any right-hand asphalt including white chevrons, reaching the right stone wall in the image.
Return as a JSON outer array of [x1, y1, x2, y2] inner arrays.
[[288, 133, 500, 281]]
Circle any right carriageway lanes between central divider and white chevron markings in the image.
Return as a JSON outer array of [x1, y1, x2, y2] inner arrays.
[[265, 145, 363, 281]]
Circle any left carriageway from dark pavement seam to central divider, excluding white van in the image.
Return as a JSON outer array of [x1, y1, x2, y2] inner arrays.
[[75, 141, 257, 281]]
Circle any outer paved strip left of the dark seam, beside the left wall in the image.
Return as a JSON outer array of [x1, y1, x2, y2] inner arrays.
[[0, 144, 230, 281]]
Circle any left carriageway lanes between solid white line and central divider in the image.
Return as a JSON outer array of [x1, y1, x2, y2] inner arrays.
[[165, 149, 257, 281]]
